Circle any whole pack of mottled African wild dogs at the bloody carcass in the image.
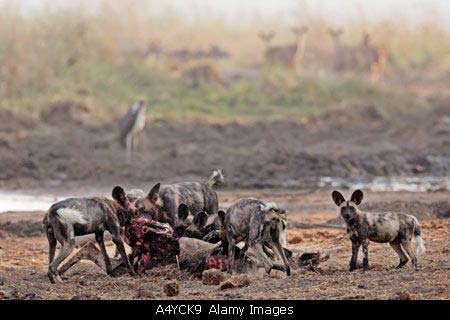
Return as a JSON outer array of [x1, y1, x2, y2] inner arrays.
[[43, 170, 425, 283]]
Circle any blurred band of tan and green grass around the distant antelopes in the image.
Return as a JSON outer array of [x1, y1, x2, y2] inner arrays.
[[0, 1, 450, 121]]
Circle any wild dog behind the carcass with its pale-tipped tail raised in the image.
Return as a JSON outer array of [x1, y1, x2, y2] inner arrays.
[[136, 170, 224, 228]]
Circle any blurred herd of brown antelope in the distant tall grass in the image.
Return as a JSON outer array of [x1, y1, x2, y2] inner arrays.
[[141, 26, 389, 87]]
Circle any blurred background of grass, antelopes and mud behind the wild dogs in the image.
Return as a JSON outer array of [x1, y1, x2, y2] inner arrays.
[[0, 0, 450, 190]]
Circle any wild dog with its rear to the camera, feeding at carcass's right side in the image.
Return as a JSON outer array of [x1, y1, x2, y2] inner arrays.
[[220, 198, 291, 275]]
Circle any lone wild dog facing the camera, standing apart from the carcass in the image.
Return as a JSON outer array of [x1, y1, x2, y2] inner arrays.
[[332, 190, 425, 271]]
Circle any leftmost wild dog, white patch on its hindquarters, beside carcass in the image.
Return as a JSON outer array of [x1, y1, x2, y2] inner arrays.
[[43, 186, 136, 283]]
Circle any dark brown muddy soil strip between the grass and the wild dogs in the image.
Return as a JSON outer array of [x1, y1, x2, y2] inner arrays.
[[0, 101, 450, 189]]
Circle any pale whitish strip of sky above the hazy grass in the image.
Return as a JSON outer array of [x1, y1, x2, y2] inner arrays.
[[6, 0, 450, 30]]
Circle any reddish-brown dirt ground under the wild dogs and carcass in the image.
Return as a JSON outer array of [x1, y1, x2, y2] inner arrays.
[[0, 190, 450, 299]]
